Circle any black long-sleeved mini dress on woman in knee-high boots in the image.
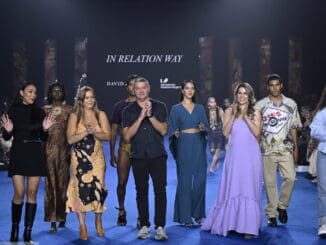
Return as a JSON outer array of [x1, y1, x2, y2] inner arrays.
[[3, 103, 47, 177]]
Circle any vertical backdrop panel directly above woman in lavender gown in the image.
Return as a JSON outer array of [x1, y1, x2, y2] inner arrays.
[[229, 38, 243, 94]]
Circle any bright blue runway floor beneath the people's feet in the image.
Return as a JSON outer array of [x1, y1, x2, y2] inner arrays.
[[0, 140, 326, 245]]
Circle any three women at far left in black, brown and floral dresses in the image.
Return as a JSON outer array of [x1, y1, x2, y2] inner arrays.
[[1, 82, 111, 243]]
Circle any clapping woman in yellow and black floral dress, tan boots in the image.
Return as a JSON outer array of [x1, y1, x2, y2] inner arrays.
[[66, 86, 110, 240]]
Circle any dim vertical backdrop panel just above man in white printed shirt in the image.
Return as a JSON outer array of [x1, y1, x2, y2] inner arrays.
[[258, 38, 272, 97]]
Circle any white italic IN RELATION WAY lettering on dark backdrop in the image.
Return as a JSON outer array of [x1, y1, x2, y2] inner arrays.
[[106, 54, 183, 64]]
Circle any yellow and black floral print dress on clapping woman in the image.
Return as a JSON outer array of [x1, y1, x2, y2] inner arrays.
[[66, 123, 107, 213]]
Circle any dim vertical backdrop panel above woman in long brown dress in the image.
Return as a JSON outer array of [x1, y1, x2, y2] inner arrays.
[[44, 39, 57, 97]]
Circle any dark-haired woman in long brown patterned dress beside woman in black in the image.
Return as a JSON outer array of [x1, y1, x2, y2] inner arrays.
[[43, 82, 72, 232]]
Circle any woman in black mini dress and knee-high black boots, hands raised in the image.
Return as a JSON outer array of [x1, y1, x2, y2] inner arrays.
[[1, 82, 55, 242]]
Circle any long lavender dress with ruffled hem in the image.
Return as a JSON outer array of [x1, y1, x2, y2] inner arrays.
[[202, 119, 262, 236]]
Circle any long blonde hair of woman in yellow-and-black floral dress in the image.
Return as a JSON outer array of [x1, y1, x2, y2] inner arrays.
[[74, 86, 100, 125]]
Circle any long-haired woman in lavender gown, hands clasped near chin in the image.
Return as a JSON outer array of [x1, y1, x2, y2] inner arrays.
[[202, 83, 262, 238]]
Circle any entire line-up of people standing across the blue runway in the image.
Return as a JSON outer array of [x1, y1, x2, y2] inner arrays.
[[1, 74, 326, 242]]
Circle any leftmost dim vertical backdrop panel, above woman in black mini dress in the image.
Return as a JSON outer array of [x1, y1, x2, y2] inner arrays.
[[12, 41, 28, 96]]
